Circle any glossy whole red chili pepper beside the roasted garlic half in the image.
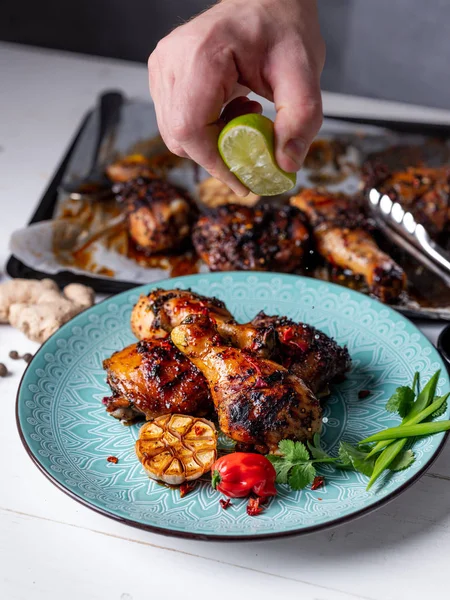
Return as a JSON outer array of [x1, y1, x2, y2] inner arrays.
[[211, 452, 277, 498]]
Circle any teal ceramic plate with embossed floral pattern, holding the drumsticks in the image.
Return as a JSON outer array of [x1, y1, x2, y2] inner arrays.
[[17, 273, 450, 539]]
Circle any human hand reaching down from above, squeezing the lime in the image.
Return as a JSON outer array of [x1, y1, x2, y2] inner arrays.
[[148, 0, 325, 196]]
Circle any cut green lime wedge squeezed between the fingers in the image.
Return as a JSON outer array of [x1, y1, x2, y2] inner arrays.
[[218, 114, 297, 196]]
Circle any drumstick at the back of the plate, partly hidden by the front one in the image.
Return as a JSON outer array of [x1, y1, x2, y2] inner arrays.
[[131, 289, 275, 356]]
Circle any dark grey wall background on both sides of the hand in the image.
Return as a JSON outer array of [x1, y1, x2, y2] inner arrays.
[[0, 0, 450, 108]]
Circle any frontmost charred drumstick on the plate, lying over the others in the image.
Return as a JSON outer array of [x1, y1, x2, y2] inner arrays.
[[171, 315, 321, 452]]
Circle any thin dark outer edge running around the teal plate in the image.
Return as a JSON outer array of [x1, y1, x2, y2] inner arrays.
[[15, 271, 450, 542]]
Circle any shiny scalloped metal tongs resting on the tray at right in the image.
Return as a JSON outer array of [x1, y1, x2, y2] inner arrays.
[[369, 188, 450, 287]]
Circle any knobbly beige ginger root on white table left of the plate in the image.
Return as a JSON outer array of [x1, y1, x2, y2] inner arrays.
[[0, 279, 94, 343]]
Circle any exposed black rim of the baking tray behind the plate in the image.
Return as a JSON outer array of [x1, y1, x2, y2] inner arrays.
[[6, 98, 450, 300]]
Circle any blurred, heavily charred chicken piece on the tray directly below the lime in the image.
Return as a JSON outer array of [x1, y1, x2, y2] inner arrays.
[[192, 204, 309, 273]]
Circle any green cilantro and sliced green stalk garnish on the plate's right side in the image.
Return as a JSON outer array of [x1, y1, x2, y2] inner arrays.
[[267, 371, 450, 490]]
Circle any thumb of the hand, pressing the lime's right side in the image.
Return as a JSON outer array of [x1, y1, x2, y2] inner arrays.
[[272, 59, 323, 172]]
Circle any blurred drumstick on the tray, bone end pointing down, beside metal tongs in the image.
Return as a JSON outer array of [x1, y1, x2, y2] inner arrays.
[[291, 189, 406, 302]]
